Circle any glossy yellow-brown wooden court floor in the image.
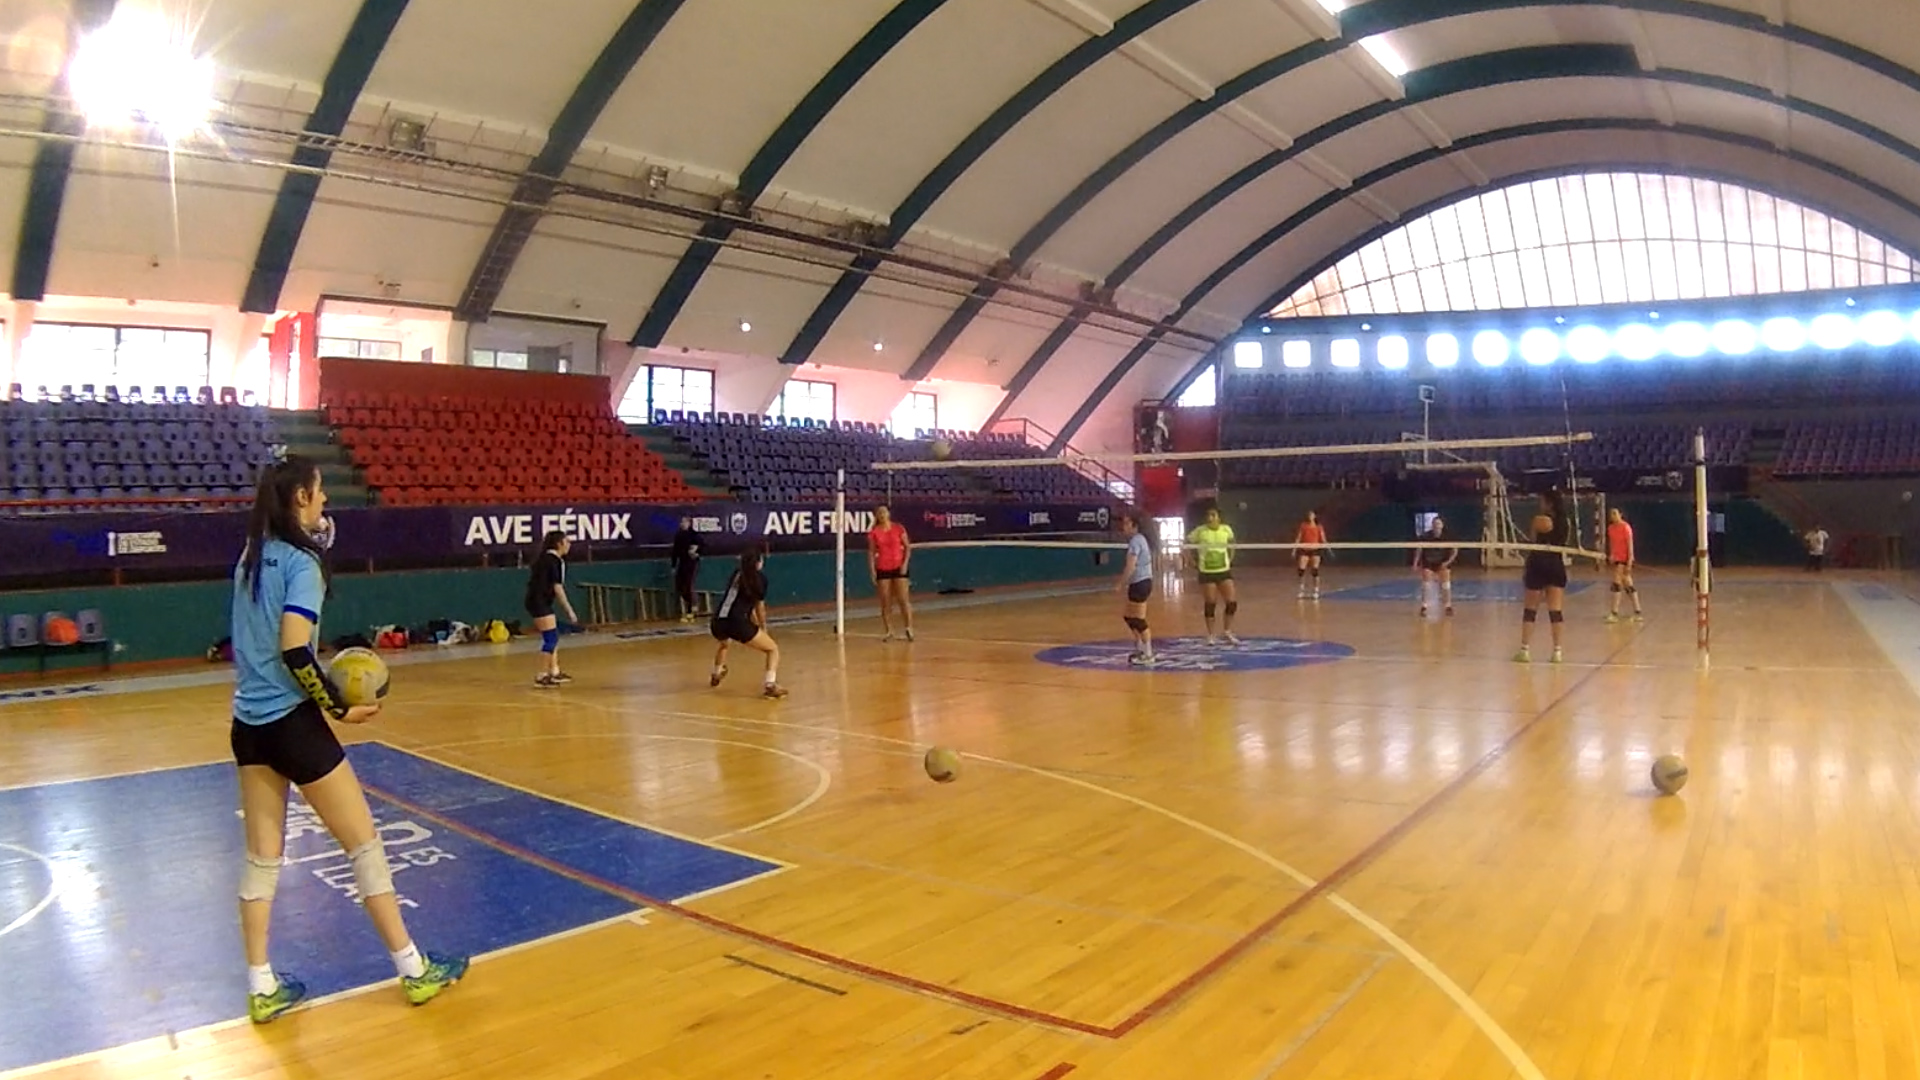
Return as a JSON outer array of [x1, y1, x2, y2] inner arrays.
[[0, 571, 1920, 1080]]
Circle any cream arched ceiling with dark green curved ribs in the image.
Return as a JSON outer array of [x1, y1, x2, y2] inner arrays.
[[0, 0, 1920, 445]]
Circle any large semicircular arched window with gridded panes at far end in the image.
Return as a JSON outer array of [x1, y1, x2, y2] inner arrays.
[[1271, 173, 1916, 317]]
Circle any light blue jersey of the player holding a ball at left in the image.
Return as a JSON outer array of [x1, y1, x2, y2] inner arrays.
[[232, 540, 326, 724]]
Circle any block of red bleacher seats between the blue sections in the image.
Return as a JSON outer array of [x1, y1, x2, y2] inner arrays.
[[323, 390, 699, 505]]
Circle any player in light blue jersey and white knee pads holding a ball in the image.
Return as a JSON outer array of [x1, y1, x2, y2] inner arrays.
[[230, 457, 467, 1024]]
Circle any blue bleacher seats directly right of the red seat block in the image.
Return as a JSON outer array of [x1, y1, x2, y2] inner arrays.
[[655, 413, 1112, 503]]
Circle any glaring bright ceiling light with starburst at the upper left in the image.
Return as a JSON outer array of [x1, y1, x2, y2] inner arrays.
[[67, 6, 215, 142]]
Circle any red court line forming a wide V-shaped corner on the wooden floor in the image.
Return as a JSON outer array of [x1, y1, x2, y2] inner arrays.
[[363, 634, 1638, 1037]]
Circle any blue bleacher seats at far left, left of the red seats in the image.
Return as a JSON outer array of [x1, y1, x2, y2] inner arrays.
[[0, 397, 275, 513]]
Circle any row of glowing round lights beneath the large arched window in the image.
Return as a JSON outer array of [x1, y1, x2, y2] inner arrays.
[[1233, 311, 1920, 371]]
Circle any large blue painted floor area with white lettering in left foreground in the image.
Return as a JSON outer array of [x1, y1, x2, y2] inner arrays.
[[0, 744, 778, 1070]]
